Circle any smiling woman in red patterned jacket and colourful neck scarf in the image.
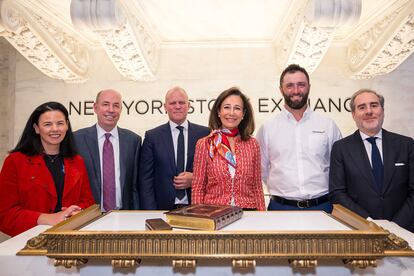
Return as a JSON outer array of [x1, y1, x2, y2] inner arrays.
[[192, 88, 265, 210]]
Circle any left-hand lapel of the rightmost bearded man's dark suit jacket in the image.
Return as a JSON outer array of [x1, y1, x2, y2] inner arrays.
[[349, 130, 379, 192]]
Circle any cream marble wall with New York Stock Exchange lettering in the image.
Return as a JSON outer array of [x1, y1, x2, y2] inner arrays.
[[0, 40, 414, 166]]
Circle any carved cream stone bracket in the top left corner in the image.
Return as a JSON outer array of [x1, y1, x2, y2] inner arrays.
[[0, 0, 89, 82]]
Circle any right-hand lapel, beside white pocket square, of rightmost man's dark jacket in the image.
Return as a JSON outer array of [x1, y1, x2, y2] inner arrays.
[[382, 129, 398, 192]]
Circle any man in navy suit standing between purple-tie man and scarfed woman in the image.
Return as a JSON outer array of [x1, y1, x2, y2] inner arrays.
[[139, 87, 209, 210]]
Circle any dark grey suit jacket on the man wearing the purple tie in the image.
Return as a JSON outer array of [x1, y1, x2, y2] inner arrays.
[[74, 125, 141, 210]]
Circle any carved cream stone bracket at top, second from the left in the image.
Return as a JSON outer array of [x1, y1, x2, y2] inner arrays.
[[71, 0, 159, 81]]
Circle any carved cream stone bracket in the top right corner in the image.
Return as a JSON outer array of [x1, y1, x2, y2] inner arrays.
[[348, 1, 414, 79]]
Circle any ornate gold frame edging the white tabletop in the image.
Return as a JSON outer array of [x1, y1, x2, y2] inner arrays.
[[18, 205, 414, 268]]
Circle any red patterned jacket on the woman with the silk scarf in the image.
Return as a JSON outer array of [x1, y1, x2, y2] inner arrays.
[[191, 137, 265, 210]]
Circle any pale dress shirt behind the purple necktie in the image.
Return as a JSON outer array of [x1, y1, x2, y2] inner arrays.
[[96, 124, 122, 209]]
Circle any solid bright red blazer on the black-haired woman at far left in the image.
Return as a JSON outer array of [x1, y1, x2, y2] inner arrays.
[[0, 152, 94, 236]]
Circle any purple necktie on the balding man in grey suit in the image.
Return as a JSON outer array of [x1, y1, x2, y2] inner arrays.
[[102, 133, 116, 212]]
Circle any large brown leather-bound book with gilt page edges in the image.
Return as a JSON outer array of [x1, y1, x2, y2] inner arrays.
[[165, 204, 243, 230]]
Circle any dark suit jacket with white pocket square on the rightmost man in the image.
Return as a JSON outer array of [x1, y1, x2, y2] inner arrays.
[[329, 130, 414, 231]]
